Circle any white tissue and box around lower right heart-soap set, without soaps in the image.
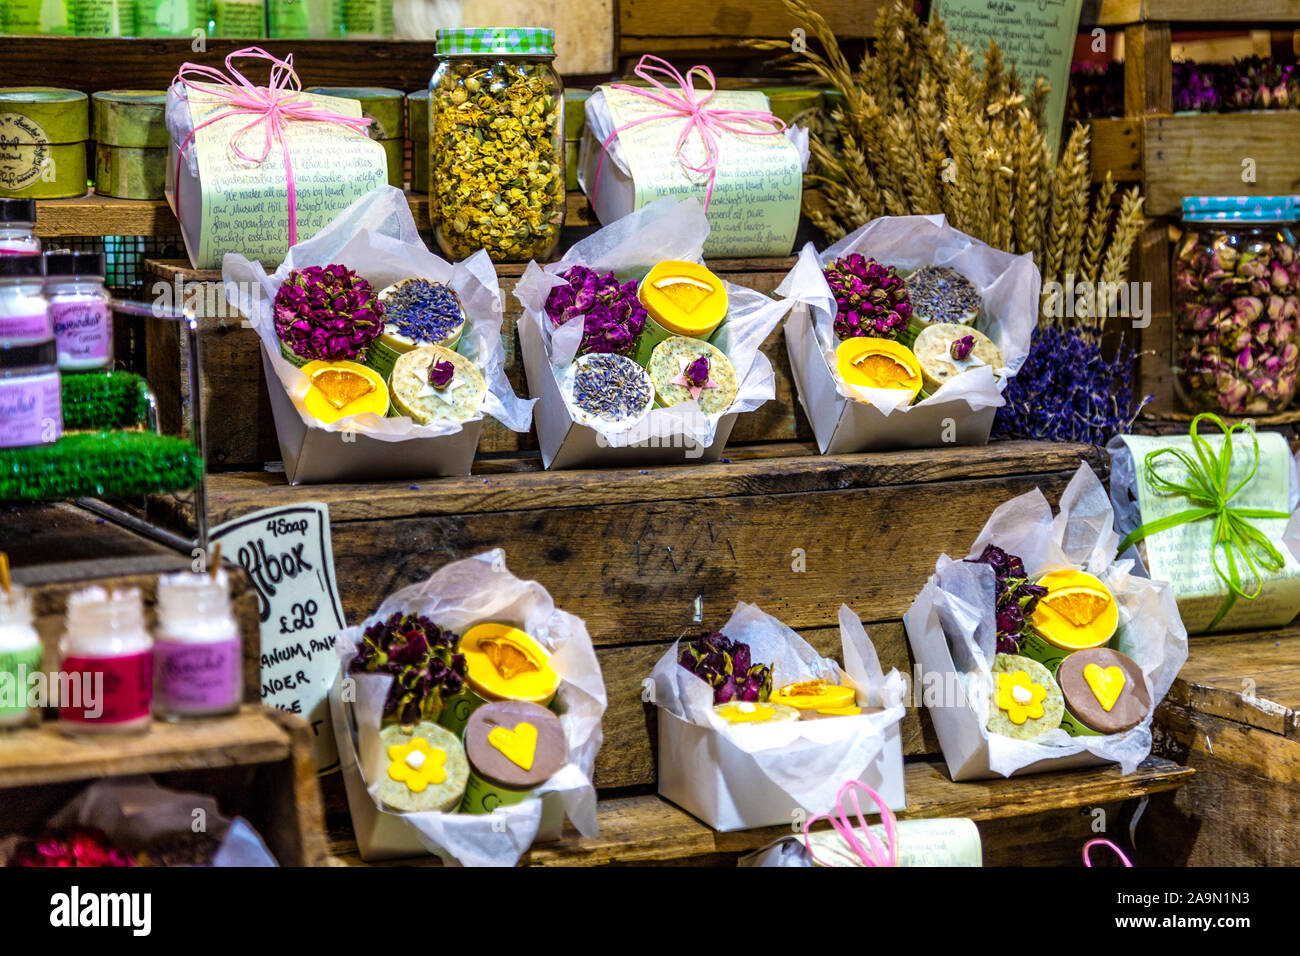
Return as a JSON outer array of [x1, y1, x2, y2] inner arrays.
[[904, 463, 1187, 780]]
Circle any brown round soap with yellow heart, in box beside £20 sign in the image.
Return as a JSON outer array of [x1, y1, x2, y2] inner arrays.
[[465, 700, 568, 791]]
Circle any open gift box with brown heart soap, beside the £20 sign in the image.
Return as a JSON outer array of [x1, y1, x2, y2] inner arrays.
[[330, 549, 606, 866]]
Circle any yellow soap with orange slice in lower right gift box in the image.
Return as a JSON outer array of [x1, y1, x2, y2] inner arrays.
[[1021, 568, 1119, 671]]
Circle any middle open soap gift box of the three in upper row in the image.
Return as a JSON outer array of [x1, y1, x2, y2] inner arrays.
[[515, 198, 788, 468]]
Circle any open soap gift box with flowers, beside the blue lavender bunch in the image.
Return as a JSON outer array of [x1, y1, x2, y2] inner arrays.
[[776, 216, 1041, 454]]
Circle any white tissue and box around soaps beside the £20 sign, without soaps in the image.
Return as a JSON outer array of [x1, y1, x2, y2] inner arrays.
[[330, 549, 606, 866]]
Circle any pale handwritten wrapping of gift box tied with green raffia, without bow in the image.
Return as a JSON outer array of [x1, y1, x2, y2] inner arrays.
[[1123, 432, 1300, 633]]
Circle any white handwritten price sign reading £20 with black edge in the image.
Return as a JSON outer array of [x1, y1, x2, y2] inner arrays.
[[211, 502, 346, 773]]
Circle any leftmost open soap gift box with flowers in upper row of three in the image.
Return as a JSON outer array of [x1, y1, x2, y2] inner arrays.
[[222, 186, 532, 484]]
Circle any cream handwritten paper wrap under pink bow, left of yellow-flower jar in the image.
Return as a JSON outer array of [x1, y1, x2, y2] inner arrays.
[[190, 87, 389, 267]]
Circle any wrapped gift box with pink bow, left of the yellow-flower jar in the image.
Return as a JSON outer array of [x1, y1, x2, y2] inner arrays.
[[166, 49, 389, 269]]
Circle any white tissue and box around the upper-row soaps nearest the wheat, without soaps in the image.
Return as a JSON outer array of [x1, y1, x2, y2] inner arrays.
[[776, 216, 1041, 454]]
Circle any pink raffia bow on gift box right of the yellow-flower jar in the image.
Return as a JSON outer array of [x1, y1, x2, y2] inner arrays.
[[592, 53, 785, 212]]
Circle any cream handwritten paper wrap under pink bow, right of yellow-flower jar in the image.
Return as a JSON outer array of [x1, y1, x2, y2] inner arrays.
[[603, 87, 803, 256]]
